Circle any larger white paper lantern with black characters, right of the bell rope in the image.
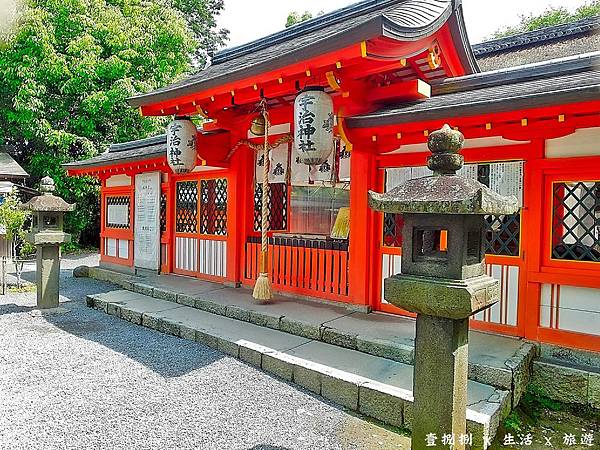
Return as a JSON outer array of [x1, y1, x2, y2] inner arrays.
[[294, 87, 334, 165]]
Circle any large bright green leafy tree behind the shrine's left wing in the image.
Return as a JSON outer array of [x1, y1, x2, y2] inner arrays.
[[0, 0, 224, 244]]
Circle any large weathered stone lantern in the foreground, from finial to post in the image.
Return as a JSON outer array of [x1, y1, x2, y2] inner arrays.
[[369, 125, 518, 450]]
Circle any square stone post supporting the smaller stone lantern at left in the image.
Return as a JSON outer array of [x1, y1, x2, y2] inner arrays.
[[36, 245, 60, 309]]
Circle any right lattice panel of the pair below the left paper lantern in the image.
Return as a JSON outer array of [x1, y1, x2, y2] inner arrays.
[[200, 178, 227, 236]]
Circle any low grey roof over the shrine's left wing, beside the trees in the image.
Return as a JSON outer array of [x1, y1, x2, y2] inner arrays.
[[63, 134, 167, 169]]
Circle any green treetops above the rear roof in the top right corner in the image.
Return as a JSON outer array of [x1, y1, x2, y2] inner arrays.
[[492, 0, 600, 39]]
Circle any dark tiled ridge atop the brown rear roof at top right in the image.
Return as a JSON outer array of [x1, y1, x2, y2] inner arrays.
[[473, 16, 600, 59]]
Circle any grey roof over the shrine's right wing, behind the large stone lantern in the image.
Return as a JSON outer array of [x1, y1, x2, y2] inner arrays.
[[347, 52, 600, 128]]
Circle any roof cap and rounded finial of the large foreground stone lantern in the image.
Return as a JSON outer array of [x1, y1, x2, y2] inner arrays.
[[369, 125, 519, 215]]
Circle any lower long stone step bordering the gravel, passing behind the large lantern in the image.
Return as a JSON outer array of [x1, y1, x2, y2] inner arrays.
[[87, 290, 511, 448]]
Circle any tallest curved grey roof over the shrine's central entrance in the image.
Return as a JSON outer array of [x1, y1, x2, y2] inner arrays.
[[129, 0, 477, 107]]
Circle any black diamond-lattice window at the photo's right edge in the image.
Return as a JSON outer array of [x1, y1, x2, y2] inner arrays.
[[552, 182, 600, 262]]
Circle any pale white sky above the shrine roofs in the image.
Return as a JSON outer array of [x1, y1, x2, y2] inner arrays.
[[218, 0, 589, 47]]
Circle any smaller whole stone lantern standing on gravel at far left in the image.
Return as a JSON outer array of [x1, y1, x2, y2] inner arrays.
[[22, 177, 75, 309]]
